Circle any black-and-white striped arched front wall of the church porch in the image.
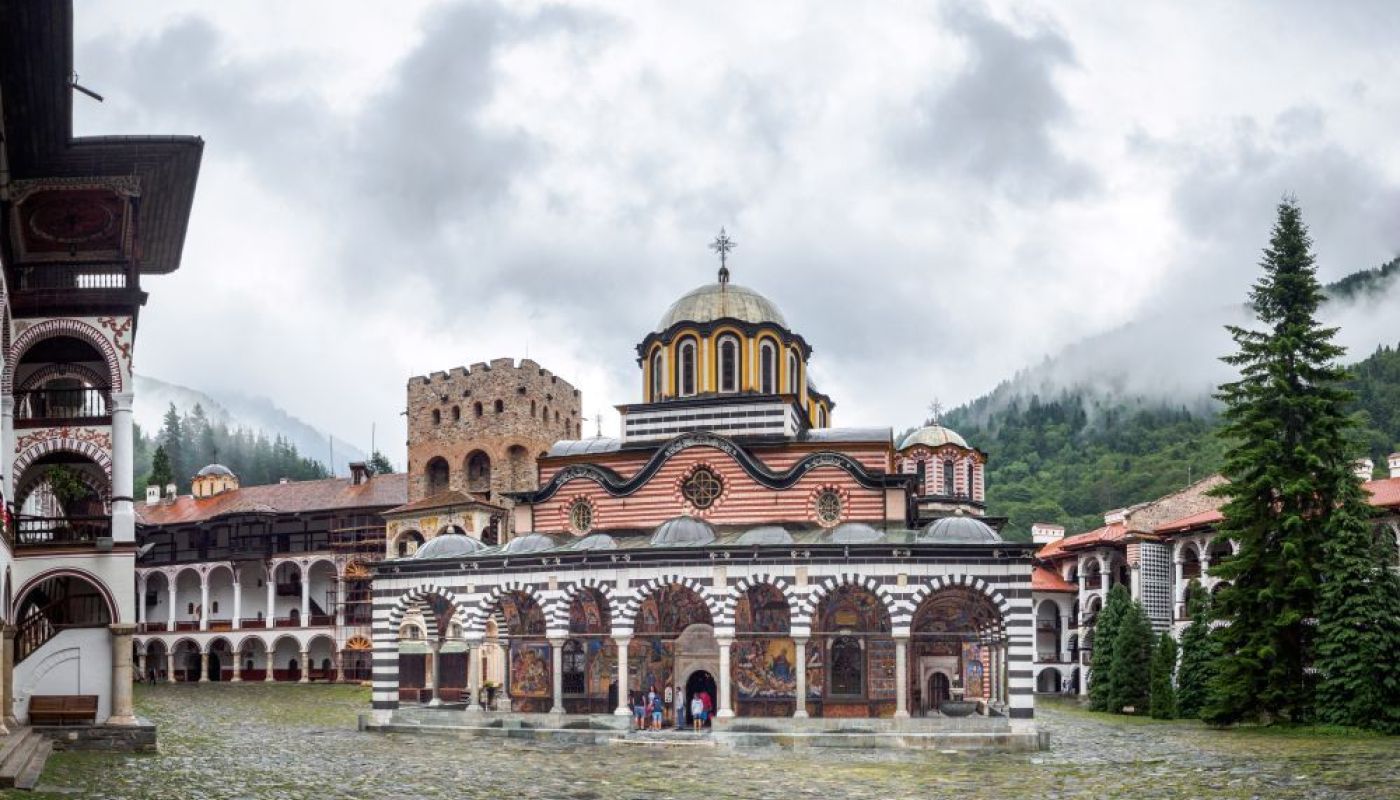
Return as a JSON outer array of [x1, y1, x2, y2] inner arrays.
[[372, 554, 1035, 720]]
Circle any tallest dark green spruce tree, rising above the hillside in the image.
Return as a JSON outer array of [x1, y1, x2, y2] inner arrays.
[[1203, 199, 1365, 724]]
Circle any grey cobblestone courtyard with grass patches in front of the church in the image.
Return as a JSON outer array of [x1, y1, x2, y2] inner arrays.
[[13, 684, 1400, 800]]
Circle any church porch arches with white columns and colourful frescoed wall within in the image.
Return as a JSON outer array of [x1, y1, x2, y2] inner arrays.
[[386, 576, 1008, 717]]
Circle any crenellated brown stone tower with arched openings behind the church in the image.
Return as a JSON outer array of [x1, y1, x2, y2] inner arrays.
[[407, 359, 582, 518]]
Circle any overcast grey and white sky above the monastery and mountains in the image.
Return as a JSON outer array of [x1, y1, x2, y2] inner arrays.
[[74, 0, 1400, 467]]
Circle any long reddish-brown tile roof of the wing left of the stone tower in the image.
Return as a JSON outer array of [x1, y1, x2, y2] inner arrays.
[[136, 472, 409, 525]]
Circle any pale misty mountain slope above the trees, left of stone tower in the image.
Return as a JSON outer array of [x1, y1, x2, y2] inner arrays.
[[133, 375, 368, 476]]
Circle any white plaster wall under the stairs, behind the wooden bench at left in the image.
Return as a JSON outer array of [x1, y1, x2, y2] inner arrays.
[[14, 628, 112, 722]]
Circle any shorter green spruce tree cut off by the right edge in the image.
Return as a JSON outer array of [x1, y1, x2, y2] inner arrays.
[[1316, 498, 1400, 733]]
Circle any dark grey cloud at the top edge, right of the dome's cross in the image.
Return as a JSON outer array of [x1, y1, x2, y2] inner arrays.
[[896, 4, 1096, 202]]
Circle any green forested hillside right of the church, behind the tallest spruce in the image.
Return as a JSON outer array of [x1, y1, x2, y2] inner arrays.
[[942, 346, 1400, 539]]
